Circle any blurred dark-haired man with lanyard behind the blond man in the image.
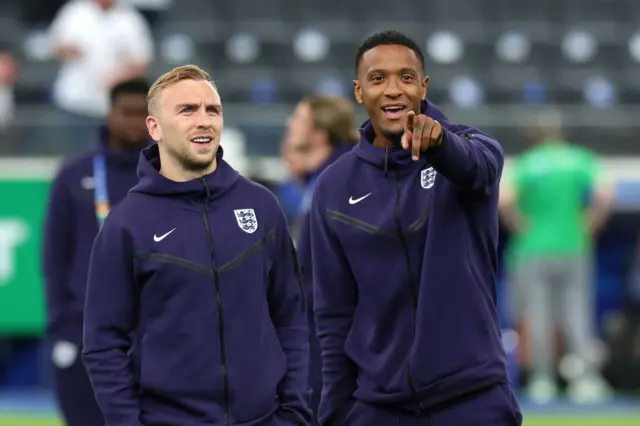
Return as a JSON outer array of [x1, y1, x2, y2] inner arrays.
[[43, 80, 150, 426]]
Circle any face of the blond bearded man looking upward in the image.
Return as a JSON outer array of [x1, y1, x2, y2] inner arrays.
[[147, 79, 223, 173]]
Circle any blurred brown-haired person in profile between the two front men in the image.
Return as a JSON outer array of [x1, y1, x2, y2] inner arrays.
[[285, 95, 358, 424]]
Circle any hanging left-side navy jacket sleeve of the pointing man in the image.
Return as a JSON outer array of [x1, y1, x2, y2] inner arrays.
[[311, 185, 358, 426]]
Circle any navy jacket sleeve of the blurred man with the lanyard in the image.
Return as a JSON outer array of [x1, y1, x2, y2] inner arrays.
[[42, 170, 77, 344]]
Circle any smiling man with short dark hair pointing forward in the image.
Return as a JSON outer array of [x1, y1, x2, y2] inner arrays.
[[311, 31, 522, 426]]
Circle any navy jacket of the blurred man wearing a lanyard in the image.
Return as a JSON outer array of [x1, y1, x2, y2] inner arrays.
[[42, 129, 145, 345]]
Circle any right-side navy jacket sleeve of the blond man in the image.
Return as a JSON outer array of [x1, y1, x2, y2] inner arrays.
[[268, 207, 311, 425]]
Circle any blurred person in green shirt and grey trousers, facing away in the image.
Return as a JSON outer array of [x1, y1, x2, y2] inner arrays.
[[500, 116, 613, 403]]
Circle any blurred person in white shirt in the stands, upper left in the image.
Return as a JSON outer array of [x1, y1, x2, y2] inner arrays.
[[49, 0, 154, 151]]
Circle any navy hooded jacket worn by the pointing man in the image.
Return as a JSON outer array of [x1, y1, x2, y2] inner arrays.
[[311, 103, 507, 425]]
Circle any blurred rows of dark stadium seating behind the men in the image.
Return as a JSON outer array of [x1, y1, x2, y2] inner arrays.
[[0, 0, 640, 155]]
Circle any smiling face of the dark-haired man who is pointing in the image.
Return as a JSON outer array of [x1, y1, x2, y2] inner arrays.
[[354, 44, 429, 145]]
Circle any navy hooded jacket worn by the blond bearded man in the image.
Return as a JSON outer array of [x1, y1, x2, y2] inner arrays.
[[83, 145, 311, 426]]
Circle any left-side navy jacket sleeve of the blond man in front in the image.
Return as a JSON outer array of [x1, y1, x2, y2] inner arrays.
[[83, 215, 141, 426]]
